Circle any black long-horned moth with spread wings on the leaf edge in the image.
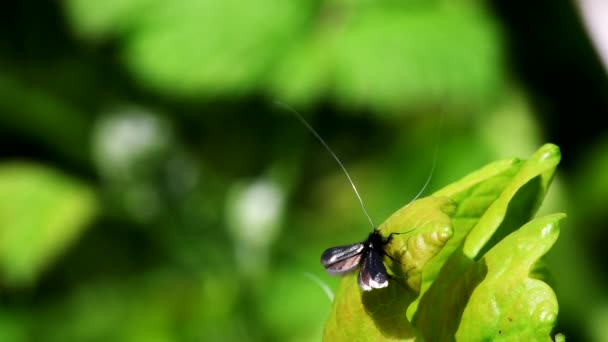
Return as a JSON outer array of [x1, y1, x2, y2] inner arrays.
[[321, 229, 397, 291]]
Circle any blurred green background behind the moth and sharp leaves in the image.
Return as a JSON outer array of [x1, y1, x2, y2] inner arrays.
[[0, 0, 608, 341]]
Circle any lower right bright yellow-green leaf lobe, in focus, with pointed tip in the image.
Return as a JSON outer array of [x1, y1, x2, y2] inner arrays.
[[456, 214, 565, 341]]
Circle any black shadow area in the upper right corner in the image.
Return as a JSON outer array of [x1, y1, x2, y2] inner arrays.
[[491, 0, 608, 171]]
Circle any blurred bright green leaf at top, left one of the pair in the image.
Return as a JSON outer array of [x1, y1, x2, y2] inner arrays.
[[67, 0, 307, 96]]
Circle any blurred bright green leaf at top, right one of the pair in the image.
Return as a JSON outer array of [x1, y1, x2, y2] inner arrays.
[[334, 5, 501, 110]]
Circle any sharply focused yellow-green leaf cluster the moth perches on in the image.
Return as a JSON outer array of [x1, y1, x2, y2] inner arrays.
[[325, 145, 564, 341]]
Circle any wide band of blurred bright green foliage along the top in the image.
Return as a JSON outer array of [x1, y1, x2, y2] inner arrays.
[[66, 0, 502, 113]]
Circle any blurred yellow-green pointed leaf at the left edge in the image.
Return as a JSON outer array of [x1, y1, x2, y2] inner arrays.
[[0, 163, 97, 285]]
